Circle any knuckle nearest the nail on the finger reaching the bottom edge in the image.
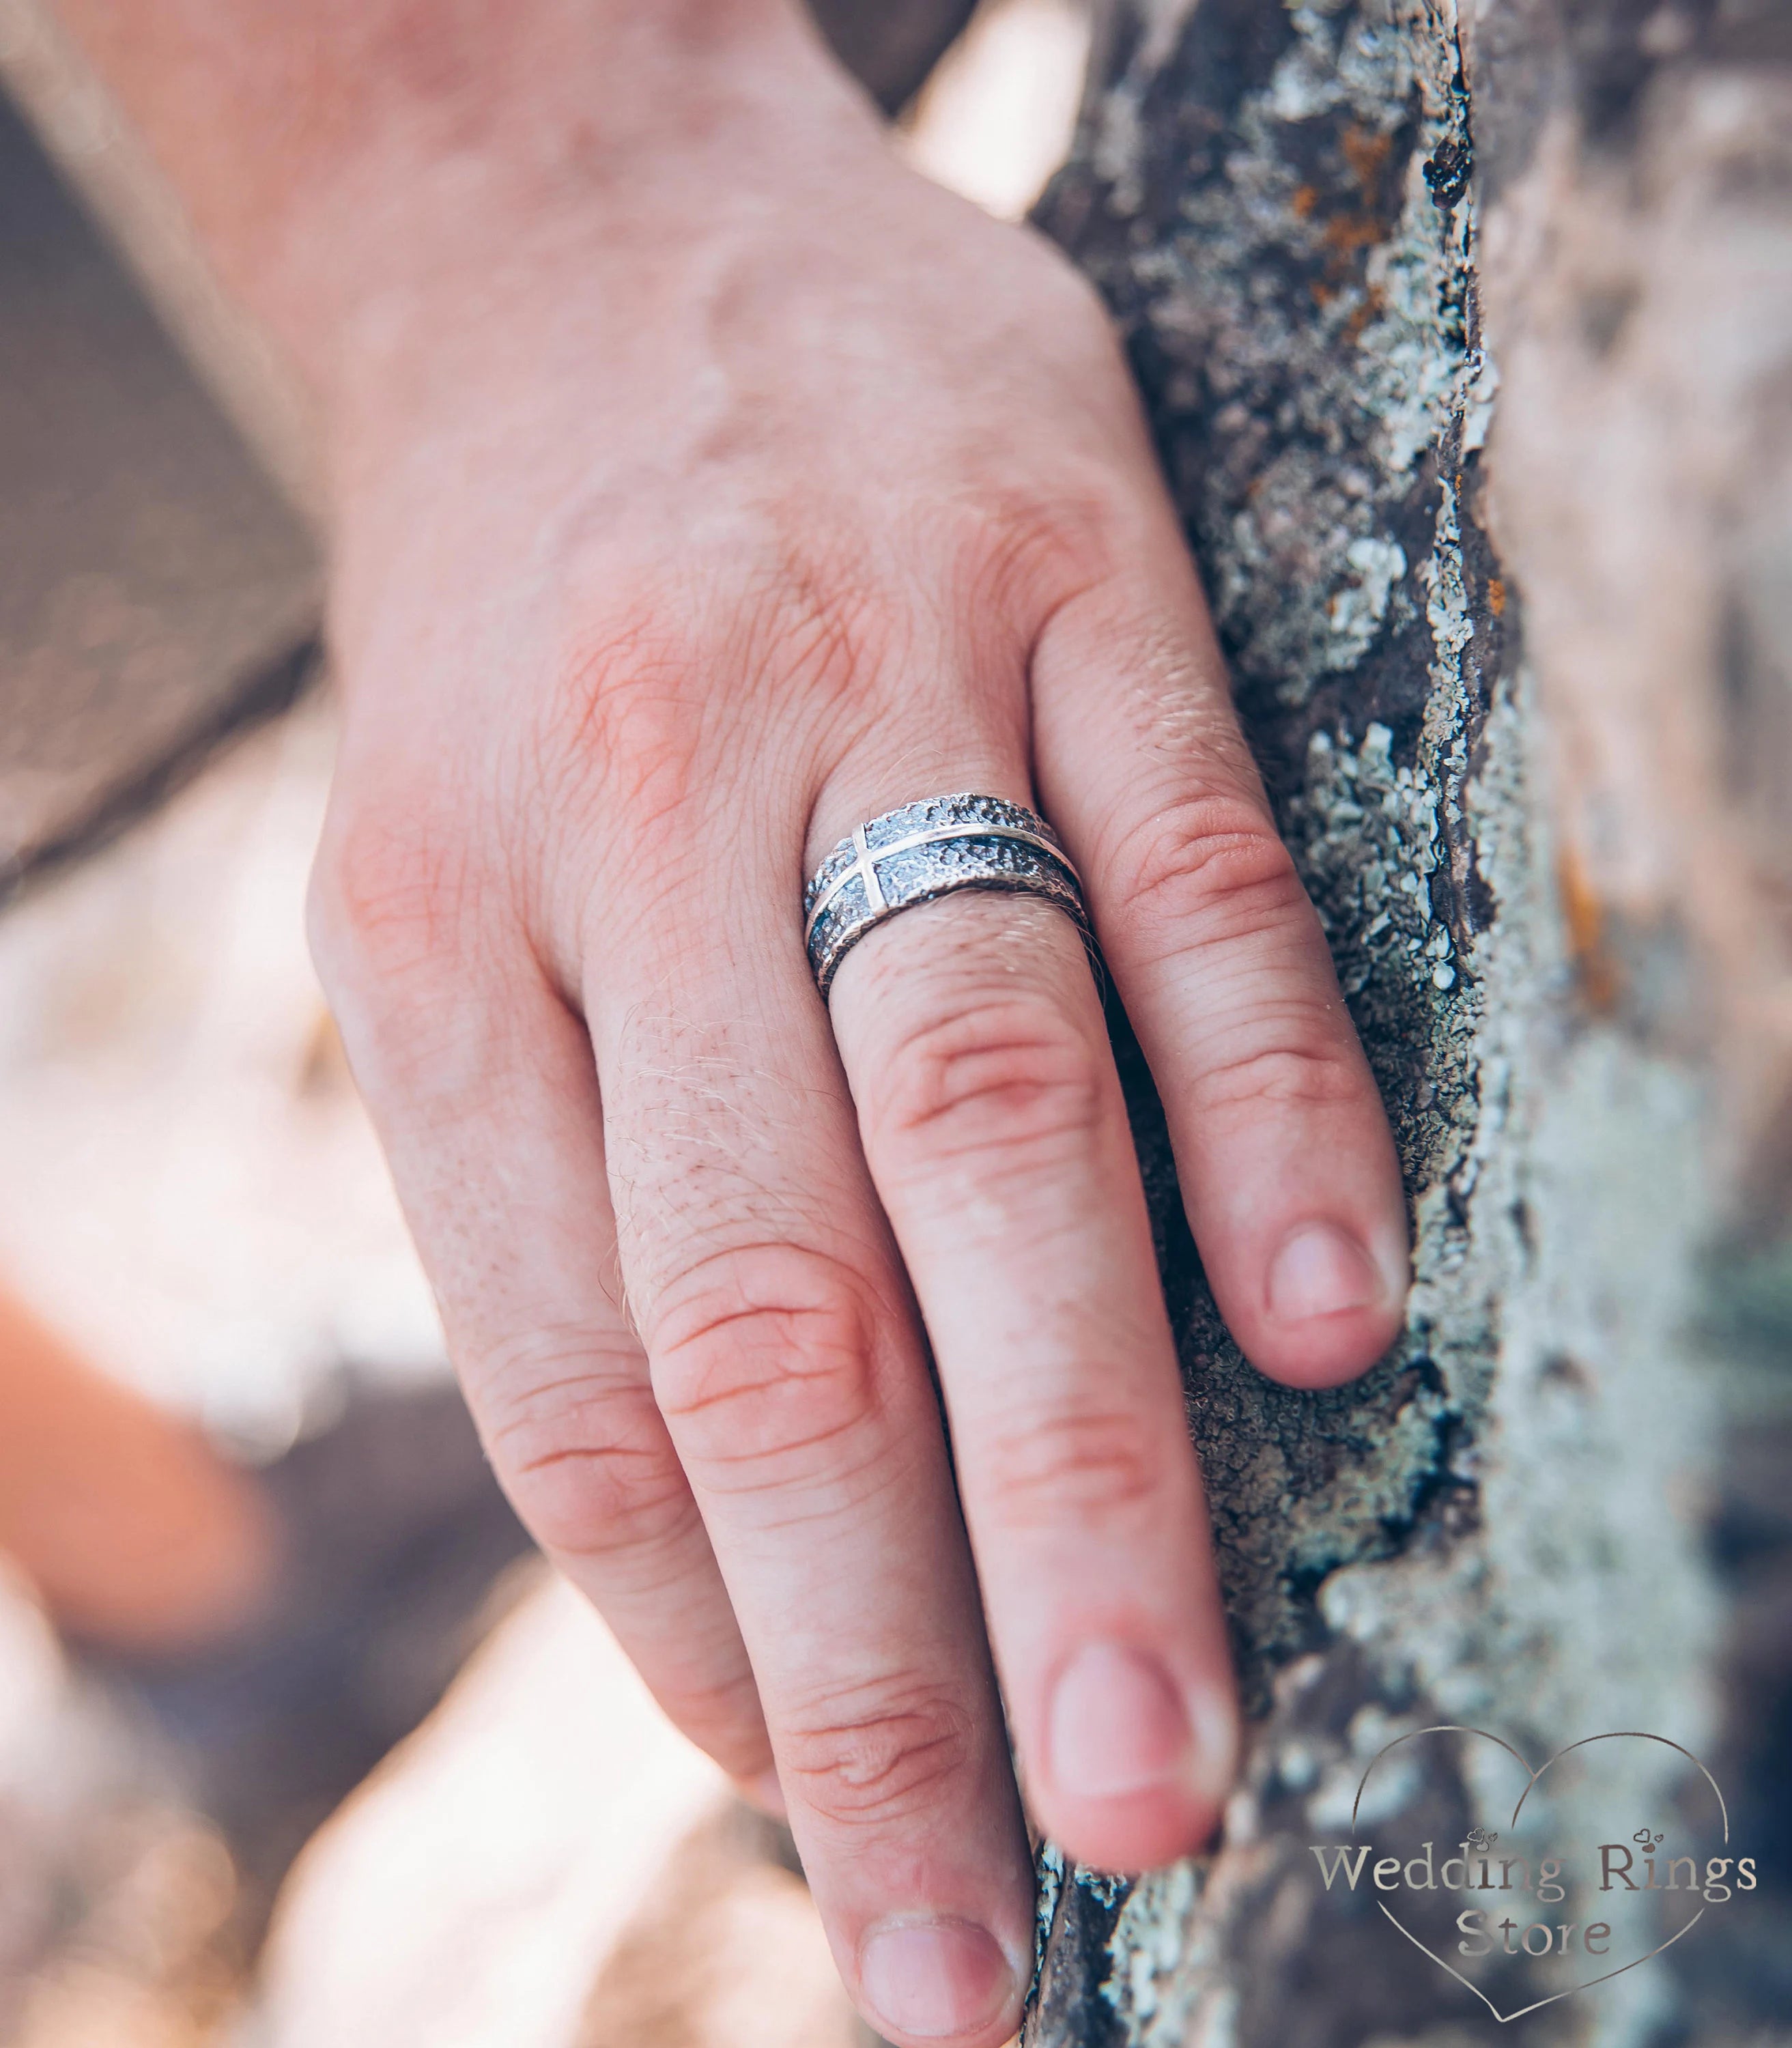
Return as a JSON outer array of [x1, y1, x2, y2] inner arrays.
[[778, 1679, 977, 1827]]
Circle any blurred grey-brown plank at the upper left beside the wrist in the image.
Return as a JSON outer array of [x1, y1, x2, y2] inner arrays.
[[0, 88, 319, 897]]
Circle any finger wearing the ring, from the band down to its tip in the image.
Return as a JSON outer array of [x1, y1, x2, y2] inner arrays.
[[829, 791, 1237, 1870]]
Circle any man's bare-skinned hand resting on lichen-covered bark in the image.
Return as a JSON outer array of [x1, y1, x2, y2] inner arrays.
[[56, 0, 1407, 2044]]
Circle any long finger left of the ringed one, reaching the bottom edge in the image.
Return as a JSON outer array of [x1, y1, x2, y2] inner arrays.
[[586, 782, 1032, 2048]]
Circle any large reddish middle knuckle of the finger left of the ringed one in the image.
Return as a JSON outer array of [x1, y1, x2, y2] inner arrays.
[[649, 1245, 883, 1493]]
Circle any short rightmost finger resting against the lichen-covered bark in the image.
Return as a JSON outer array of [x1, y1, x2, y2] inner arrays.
[[1034, 541, 1407, 1386]]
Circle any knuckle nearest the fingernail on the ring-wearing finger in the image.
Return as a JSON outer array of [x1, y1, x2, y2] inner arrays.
[[977, 1405, 1180, 1530]]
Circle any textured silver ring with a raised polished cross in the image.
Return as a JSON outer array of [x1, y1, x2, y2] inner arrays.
[[803, 793, 1100, 1001]]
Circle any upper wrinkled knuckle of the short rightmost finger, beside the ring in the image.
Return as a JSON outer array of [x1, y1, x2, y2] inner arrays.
[[1108, 797, 1307, 954]]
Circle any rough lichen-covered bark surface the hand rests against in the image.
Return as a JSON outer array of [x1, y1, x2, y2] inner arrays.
[[1028, 0, 1792, 2048]]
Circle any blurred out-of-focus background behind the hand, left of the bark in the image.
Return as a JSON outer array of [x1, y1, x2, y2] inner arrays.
[[0, 0, 1087, 2048]]
